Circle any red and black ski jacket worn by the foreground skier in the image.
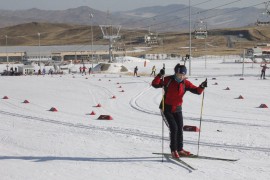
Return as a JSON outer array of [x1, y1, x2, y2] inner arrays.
[[152, 75, 203, 112]]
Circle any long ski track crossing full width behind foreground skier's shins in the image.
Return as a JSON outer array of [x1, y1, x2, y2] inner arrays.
[[0, 110, 270, 152]]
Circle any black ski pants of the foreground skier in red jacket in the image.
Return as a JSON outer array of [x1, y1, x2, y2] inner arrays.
[[163, 111, 183, 151]]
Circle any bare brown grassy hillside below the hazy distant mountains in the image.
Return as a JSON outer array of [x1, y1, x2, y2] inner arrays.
[[0, 22, 270, 56]]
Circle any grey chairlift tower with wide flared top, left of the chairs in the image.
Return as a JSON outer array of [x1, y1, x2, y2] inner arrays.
[[99, 25, 121, 63]]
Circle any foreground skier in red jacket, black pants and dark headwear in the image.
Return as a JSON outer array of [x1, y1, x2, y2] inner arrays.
[[152, 64, 207, 158]]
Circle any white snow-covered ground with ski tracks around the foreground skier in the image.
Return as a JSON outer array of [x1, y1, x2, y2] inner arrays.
[[0, 58, 270, 180]]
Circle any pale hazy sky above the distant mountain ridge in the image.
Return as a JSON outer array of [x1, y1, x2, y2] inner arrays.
[[0, 0, 266, 11]]
